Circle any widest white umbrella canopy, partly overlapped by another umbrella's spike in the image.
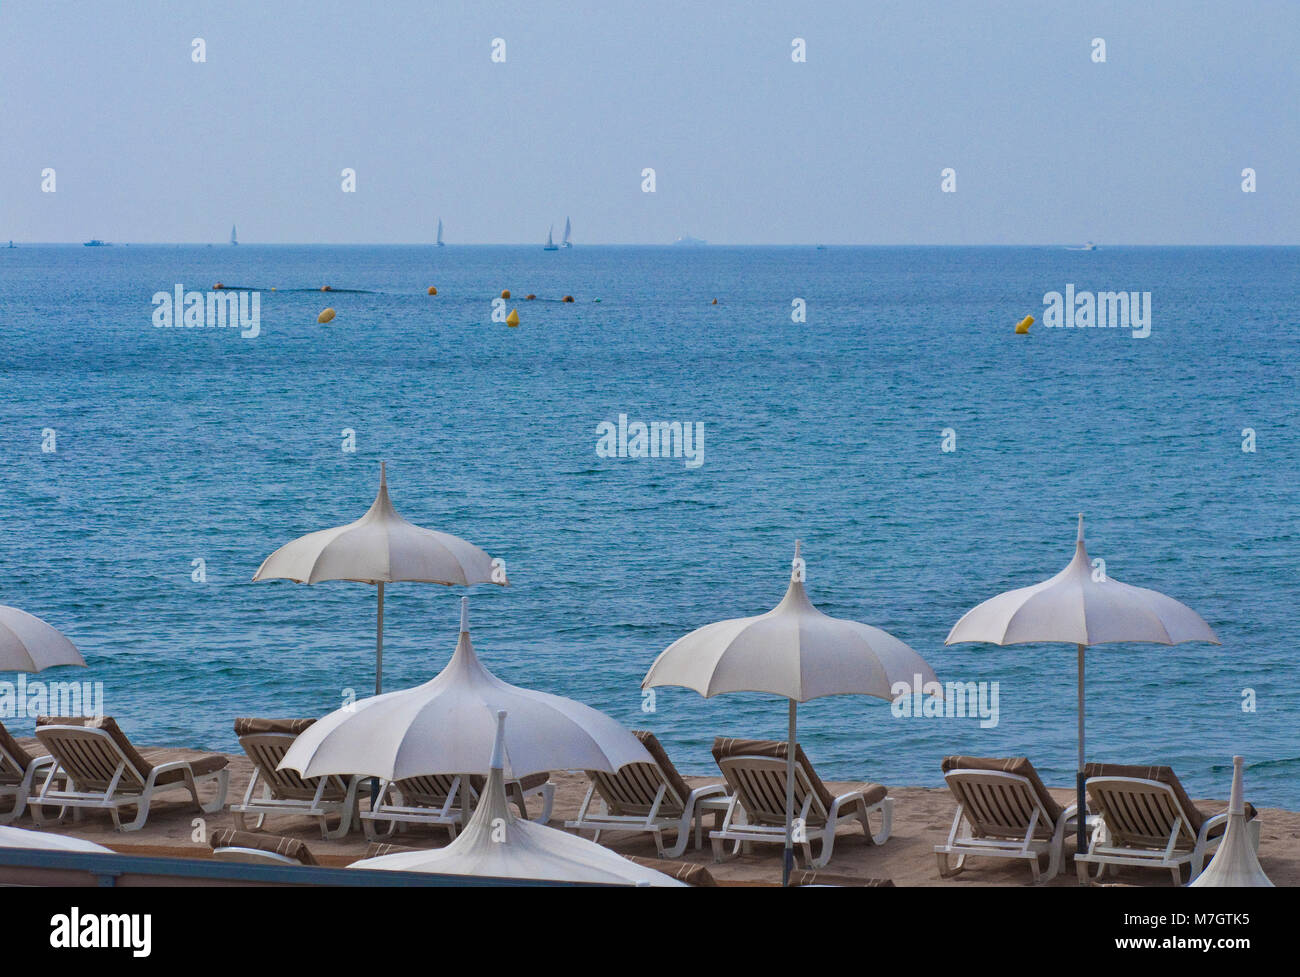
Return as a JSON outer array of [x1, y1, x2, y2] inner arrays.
[[281, 598, 653, 781]]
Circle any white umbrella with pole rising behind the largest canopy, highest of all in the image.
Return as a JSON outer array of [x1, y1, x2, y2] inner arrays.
[[252, 463, 508, 695]]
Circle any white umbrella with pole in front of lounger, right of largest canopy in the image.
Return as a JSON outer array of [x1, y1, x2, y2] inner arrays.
[[641, 542, 937, 882]]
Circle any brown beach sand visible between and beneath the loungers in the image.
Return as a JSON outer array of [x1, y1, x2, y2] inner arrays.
[[7, 739, 1300, 887]]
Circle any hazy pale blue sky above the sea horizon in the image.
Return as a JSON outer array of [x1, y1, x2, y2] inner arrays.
[[0, 0, 1300, 244]]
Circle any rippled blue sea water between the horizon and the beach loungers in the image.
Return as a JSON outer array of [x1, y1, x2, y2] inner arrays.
[[0, 246, 1300, 809]]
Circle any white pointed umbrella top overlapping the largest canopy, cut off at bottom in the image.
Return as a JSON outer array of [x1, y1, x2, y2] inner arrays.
[[350, 711, 684, 887]]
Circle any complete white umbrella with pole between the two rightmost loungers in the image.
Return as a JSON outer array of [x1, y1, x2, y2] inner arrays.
[[944, 513, 1219, 851]]
